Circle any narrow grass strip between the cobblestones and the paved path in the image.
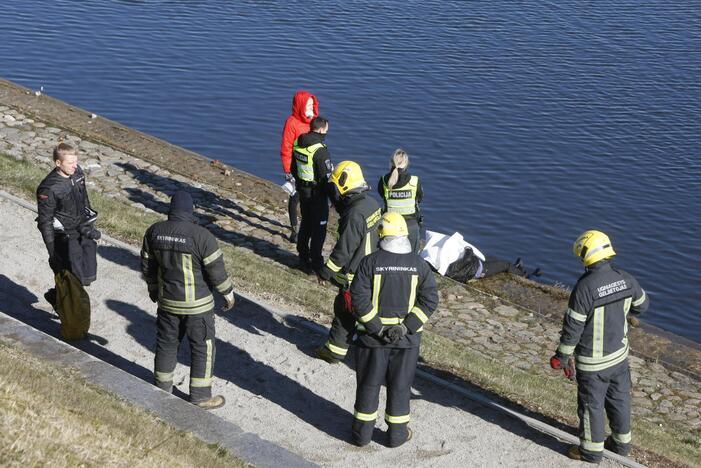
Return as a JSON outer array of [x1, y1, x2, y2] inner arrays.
[[0, 152, 701, 466]]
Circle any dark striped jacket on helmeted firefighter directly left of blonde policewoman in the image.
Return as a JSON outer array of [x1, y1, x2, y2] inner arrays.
[[319, 190, 382, 287]]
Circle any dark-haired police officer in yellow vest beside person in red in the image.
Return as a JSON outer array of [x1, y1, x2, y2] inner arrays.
[[292, 117, 333, 271]]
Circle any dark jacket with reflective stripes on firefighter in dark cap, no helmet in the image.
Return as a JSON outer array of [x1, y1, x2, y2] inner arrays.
[[141, 211, 233, 315]]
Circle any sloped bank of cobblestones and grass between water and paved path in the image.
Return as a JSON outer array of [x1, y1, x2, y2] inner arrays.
[[0, 81, 701, 464]]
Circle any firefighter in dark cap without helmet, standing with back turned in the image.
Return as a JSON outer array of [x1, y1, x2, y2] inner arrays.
[[141, 191, 234, 409]]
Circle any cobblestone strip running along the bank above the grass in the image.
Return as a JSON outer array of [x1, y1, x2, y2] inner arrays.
[[0, 105, 701, 436]]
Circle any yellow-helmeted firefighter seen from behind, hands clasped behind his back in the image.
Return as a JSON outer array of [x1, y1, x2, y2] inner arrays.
[[351, 212, 438, 447]]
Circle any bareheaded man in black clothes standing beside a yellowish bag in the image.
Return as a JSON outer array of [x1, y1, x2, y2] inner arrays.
[[36, 143, 100, 308]]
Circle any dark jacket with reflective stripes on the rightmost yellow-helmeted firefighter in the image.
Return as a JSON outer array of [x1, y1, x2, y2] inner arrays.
[[557, 260, 649, 372]]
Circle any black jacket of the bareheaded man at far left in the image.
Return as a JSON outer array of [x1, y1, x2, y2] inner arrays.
[[37, 166, 90, 255]]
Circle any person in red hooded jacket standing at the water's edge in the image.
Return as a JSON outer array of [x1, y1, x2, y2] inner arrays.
[[280, 91, 319, 242]]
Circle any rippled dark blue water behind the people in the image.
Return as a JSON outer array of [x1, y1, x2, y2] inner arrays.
[[0, 0, 701, 342]]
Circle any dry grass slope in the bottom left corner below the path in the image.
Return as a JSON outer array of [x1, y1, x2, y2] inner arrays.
[[0, 341, 247, 468]]
